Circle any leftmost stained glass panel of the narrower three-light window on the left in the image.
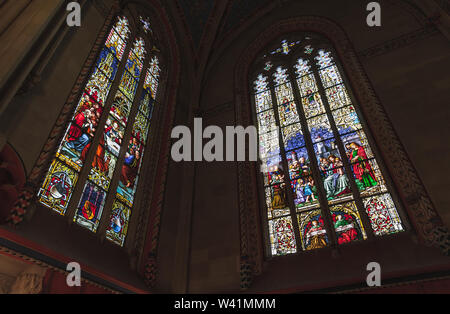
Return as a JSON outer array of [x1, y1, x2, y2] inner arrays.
[[39, 17, 130, 215]]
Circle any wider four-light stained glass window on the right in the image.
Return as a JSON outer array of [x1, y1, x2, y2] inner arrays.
[[252, 35, 404, 256]]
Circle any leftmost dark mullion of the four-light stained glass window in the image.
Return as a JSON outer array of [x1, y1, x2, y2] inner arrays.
[[269, 73, 302, 252]]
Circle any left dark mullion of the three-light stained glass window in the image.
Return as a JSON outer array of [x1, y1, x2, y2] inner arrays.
[[63, 24, 136, 224]]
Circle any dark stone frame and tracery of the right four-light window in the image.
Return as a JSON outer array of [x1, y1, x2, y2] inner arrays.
[[247, 32, 411, 259]]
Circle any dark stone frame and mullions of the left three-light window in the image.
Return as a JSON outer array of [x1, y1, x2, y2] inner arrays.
[[34, 11, 167, 251]]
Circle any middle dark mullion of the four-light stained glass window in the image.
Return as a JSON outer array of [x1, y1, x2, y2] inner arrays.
[[288, 66, 337, 247]]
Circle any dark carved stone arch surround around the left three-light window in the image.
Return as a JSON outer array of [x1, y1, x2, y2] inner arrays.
[[4, 0, 180, 286]]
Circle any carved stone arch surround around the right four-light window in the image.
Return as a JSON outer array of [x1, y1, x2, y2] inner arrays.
[[234, 16, 450, 289]]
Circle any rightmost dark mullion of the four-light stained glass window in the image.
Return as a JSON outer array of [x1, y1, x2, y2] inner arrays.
[[311, 60, 375, 239]]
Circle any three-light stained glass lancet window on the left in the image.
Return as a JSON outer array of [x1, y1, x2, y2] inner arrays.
[[38, 17, 160, 246]]
